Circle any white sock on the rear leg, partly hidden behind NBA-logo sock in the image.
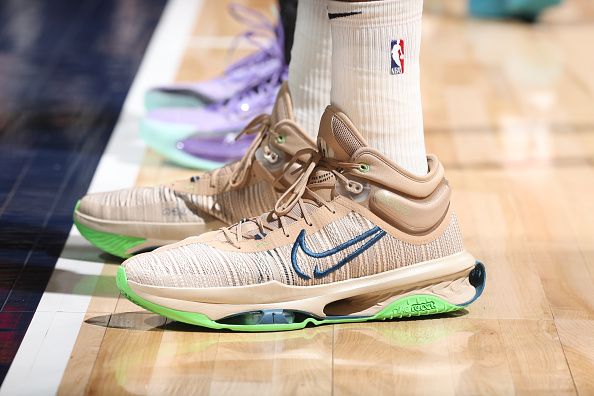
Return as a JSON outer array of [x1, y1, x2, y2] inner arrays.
[[289, 0, 332, 139]]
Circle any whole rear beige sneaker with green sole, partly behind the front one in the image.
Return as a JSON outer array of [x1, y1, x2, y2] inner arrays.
[[74, 84, 315, 257]]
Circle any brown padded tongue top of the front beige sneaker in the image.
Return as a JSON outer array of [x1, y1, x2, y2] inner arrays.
[[318, 105, 367, 161]]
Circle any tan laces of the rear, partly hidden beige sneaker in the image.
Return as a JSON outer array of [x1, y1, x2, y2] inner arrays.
[[199, 114, 282, 188]]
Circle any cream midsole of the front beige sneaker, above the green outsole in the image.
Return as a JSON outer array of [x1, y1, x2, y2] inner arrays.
[[128, 251, 476, 320]]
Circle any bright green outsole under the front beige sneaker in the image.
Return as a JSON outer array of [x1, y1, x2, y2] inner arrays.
[[116, 267, 464, 332]]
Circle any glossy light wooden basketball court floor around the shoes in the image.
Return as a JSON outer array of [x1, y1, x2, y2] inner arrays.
[[4, 0, 594, 395]]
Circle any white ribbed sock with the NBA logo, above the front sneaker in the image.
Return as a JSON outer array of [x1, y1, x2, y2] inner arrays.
[[328, 0, 427, 175]]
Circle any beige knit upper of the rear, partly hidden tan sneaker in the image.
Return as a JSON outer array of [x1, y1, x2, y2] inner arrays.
[[75, 85, 314, 237]]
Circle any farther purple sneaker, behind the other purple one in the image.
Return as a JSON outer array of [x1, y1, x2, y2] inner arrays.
[[145, 4, 285, 111]]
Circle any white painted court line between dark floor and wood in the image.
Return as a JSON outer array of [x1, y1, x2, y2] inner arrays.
[[0, 0, 202, 395]]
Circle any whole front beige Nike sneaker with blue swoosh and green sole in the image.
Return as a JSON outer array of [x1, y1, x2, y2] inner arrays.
[[117, 106, 485, 331]]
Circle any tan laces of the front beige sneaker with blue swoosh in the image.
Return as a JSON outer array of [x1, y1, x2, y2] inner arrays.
[[221, 148, 363, 249]]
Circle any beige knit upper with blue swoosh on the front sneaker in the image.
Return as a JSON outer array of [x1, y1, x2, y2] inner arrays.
[[123, 106, 463, 293]]
